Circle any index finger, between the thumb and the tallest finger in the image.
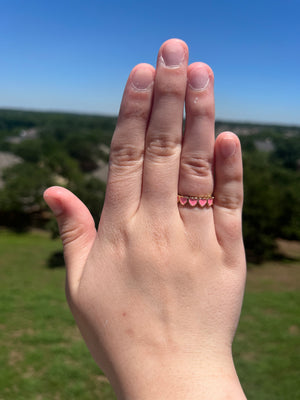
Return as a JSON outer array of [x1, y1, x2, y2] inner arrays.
[[102, 64, 155, 218]]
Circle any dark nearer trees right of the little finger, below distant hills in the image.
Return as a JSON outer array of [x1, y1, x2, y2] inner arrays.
[[243, 151, 300, 263]]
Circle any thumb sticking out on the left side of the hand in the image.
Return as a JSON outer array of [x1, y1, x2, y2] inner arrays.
[[44, 186, 96, 289]]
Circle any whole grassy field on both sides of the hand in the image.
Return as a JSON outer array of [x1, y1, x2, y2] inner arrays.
[[0, 231, 300, 400]]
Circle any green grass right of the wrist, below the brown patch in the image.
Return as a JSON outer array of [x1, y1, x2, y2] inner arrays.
[[234, 291, 300, 400]]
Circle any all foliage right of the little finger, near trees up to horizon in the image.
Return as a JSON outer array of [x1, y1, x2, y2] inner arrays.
[[234, 127, 300, 263]]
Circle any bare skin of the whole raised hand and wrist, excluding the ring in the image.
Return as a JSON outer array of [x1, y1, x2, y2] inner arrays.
[[44, 39, 246, 400]]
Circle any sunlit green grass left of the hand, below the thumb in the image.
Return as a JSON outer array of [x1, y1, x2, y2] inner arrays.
[[0, 231, 115, 400]]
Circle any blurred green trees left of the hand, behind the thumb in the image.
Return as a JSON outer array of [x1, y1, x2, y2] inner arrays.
[[0, 110, 112, 236]]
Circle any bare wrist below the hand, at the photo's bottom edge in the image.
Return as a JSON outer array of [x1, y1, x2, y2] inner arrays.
[[106, 348, 246, 400]]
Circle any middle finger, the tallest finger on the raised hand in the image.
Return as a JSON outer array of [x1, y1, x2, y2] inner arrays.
[[142, 39, 188, 211]]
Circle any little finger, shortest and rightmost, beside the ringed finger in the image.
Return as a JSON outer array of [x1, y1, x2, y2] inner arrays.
[[214, 132, 243, 249]]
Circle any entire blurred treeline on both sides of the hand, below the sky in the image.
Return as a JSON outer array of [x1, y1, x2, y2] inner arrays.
[[0, 110, 300, 263]]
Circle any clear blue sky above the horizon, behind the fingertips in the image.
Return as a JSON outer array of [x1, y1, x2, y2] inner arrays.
[[0, 0, 300, 125]]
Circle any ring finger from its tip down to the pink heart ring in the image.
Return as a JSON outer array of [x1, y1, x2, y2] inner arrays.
[[178, 63, 215, 205]]
